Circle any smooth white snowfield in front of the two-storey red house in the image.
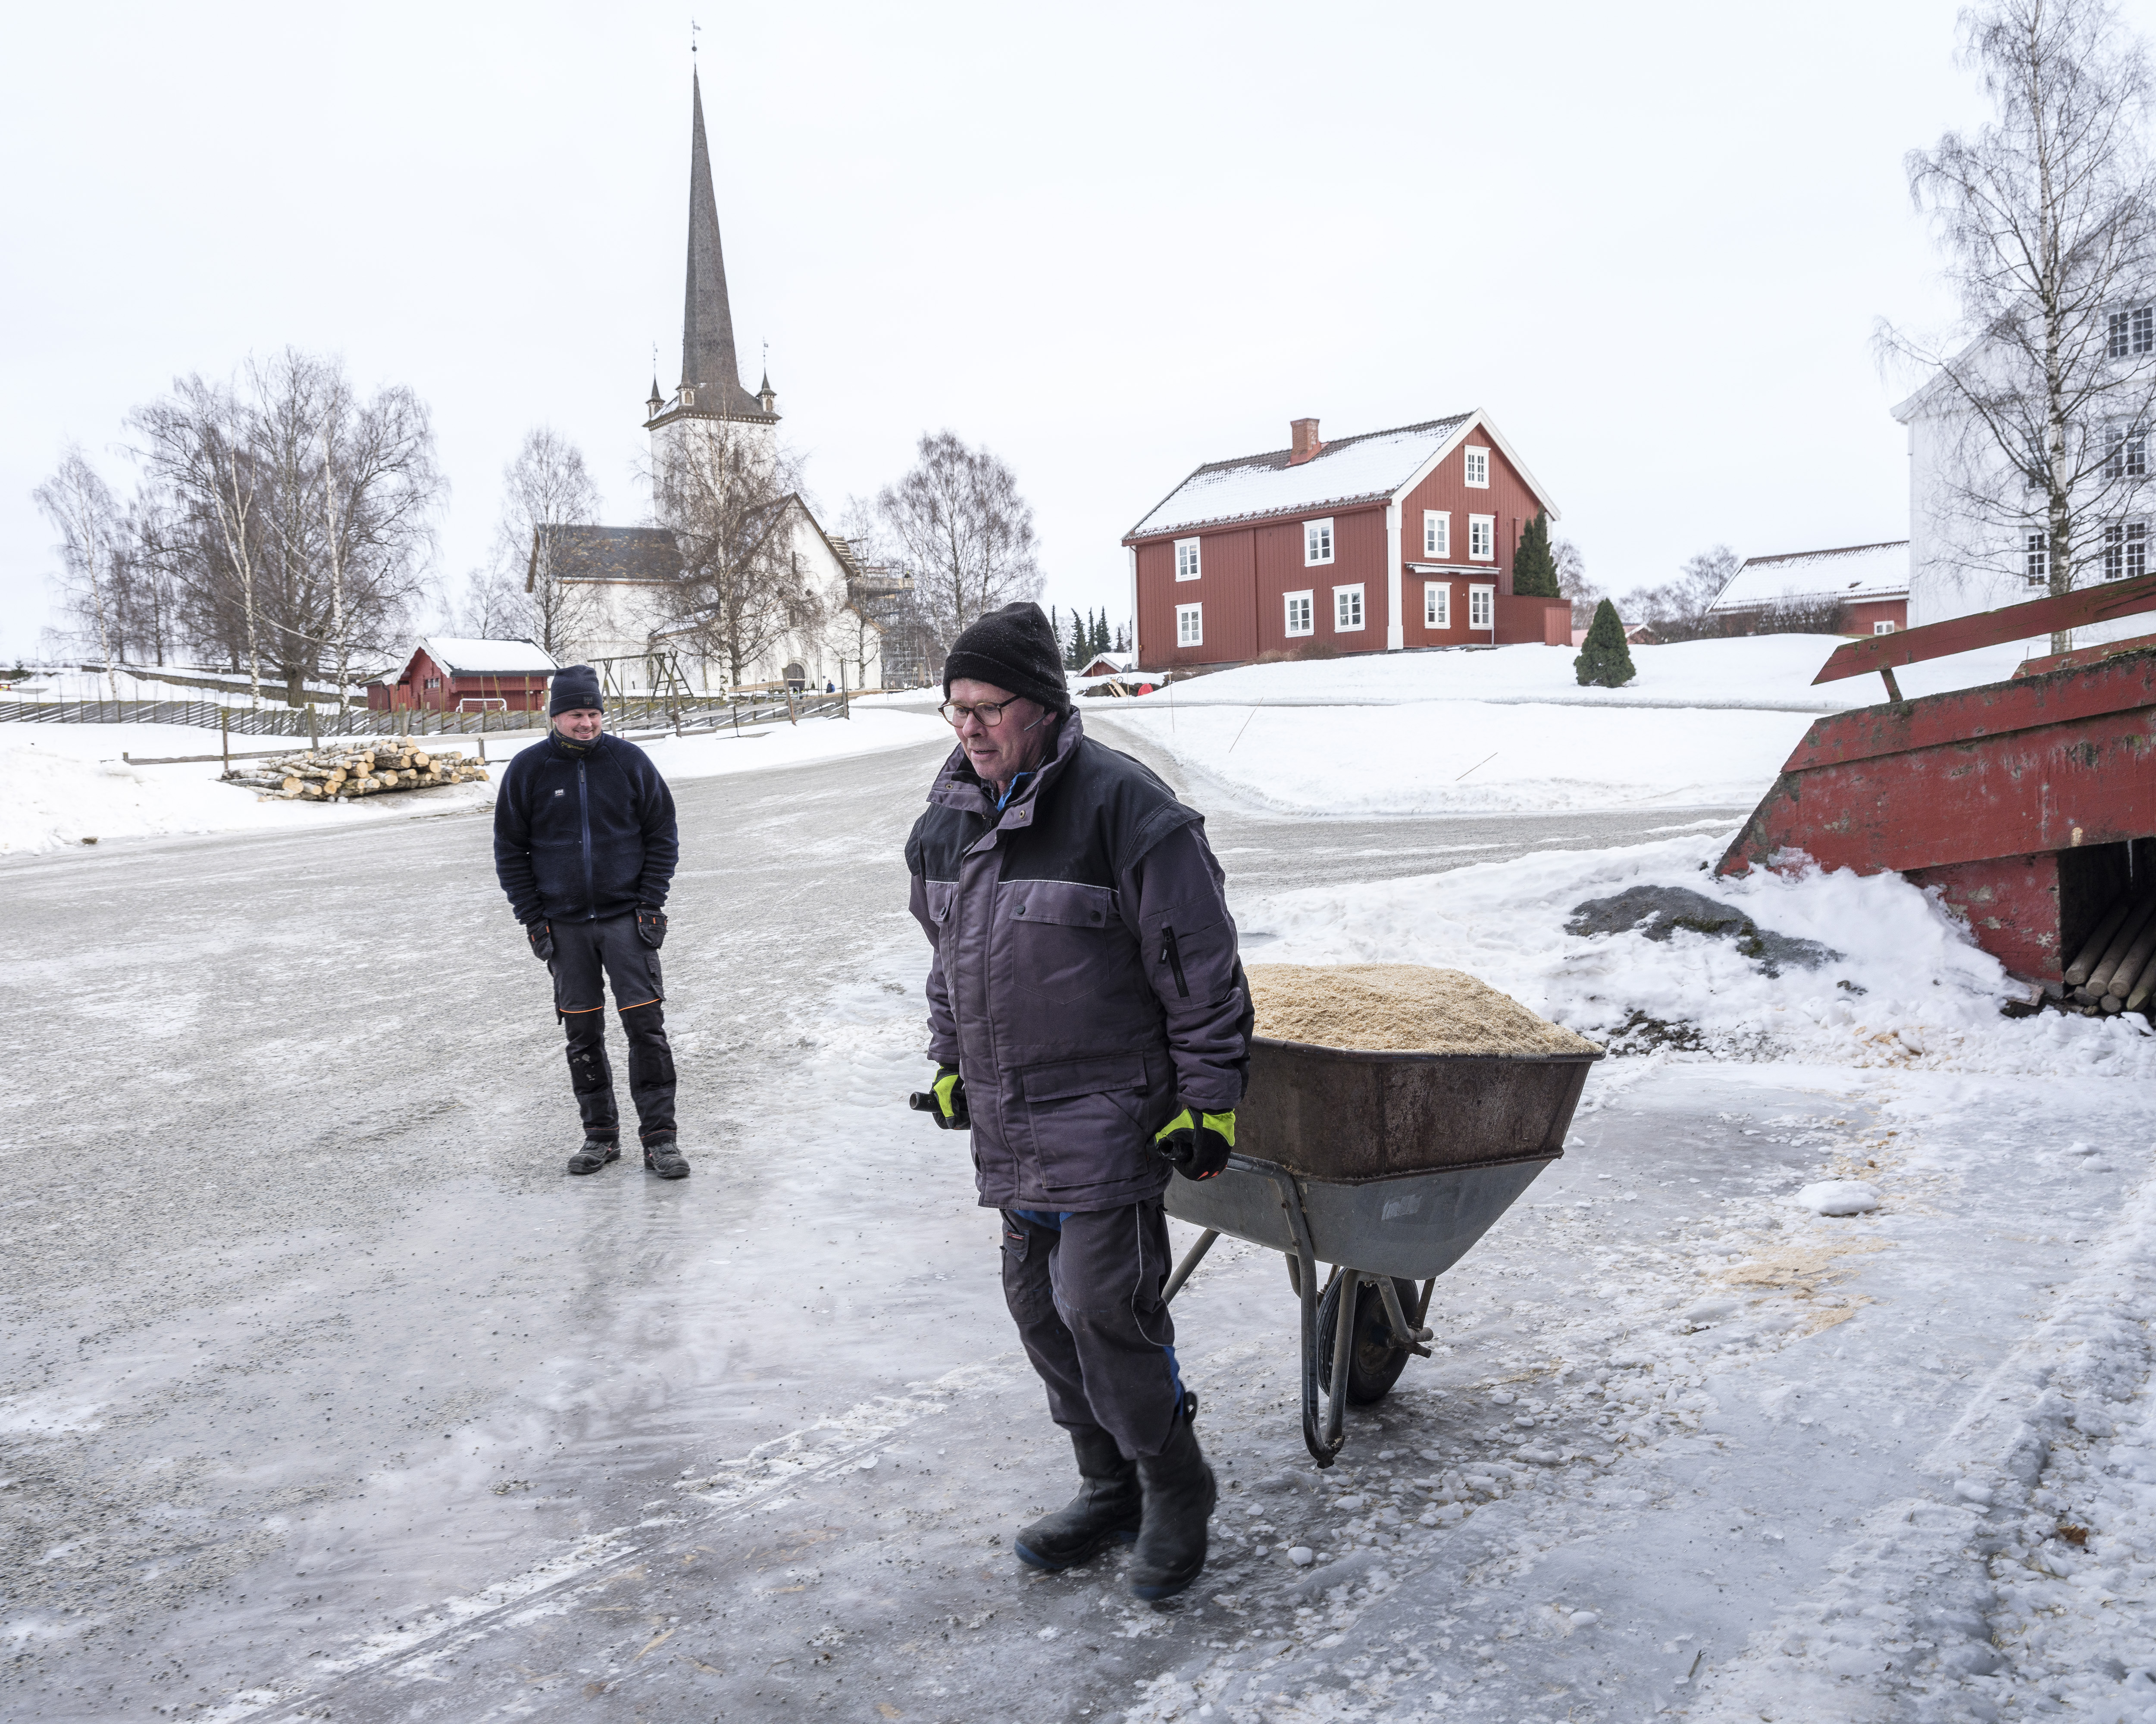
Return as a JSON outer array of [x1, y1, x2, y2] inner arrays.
[[1087, 636, 2022, 815]]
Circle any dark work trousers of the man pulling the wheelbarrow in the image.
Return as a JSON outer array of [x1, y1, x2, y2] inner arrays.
[[1002, 1198, 1184, 1459]]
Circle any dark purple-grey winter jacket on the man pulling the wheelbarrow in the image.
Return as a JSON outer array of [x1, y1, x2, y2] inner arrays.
[[905, 713, 1251, 1211]]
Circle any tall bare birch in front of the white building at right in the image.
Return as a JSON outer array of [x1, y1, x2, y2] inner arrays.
[[1878, 0, 2156, 651]]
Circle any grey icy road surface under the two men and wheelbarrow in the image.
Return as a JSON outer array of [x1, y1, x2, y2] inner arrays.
[[0, 732, 2156, 1724]]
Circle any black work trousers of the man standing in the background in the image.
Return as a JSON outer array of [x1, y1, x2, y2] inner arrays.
[[548, 916, 675, 1144]]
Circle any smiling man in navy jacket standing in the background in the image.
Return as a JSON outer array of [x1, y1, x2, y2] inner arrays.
[[494, 664, 688, 1179]]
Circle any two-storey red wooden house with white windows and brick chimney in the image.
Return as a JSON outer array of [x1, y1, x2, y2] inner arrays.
[[1123, 410, 1572, 668]]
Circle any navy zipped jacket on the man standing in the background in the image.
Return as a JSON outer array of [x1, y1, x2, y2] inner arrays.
[[494, 735, 681, 922]]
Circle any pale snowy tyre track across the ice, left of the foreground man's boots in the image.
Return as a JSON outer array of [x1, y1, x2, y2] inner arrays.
[[200, 1360, 1013, 1724]]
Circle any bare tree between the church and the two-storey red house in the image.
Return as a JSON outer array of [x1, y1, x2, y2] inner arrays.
[[875, 431, 1043, 647]]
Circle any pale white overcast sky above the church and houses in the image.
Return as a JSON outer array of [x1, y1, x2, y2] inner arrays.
[[0, 0, 2156, 653]]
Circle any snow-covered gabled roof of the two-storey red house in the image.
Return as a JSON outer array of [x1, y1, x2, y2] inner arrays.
[[1123, 410, 1557, 541]]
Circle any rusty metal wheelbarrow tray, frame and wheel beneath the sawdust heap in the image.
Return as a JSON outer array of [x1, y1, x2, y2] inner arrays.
[[1164, 1036, 1602, 1467]]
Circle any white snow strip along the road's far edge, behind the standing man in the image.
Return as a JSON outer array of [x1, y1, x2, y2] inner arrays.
[[0, 709, 948, 854]]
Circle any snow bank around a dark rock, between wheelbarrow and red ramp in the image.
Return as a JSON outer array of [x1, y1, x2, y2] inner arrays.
[[1242, 836, 2156, 1077]]
